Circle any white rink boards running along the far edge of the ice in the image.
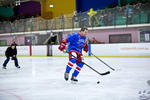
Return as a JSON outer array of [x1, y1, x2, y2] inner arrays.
[[0, 43, 150, 57]]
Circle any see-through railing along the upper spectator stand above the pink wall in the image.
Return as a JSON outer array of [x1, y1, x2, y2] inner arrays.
[[0, 3, 150, 33]]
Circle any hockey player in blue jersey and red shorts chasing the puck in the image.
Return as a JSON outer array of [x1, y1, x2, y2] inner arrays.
[[58, 28, 88, 82]]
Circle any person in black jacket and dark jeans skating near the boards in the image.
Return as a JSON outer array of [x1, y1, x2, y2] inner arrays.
[[3, 44, 20, 69]]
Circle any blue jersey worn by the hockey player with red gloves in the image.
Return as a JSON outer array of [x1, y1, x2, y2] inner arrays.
[[66, 33, 86, 54]]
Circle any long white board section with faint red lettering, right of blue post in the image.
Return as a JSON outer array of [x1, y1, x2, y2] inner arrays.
[[91, 43, 150, 56]]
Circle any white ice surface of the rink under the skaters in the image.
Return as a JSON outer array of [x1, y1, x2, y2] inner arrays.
[[0, 57, 150, 100]]
